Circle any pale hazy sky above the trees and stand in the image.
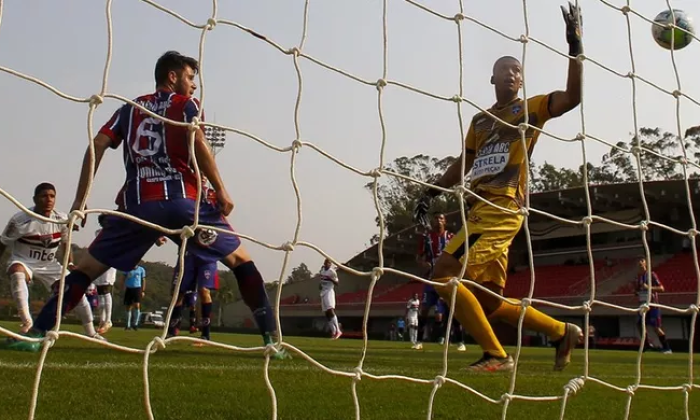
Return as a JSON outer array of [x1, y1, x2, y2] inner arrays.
[[0, 0, 700, 280]]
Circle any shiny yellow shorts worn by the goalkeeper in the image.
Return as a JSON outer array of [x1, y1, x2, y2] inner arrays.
[[444, 197, 523, 288]]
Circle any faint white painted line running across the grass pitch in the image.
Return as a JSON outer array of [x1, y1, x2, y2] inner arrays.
[[0, 362, 688, 380]]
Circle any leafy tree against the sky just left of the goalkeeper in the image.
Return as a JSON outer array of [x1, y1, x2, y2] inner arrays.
[[365, 155, 459, 243]]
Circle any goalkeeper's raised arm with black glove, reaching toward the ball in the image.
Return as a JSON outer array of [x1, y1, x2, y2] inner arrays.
[[549, 2, 583, 117]]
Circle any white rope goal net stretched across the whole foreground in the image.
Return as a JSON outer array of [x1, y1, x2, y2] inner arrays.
[[0, 0, 700, 419]]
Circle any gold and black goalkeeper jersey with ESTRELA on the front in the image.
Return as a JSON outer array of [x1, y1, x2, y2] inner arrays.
[[465, 95, 551, 204]]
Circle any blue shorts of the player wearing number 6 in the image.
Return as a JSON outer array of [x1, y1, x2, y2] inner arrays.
[[89, 198, 241, 271]]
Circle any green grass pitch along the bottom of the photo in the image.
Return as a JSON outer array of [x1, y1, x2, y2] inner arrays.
[[0, 323, 700, 420]]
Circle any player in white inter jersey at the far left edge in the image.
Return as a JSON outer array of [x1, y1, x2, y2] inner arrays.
[[0, 182, 101, 339]]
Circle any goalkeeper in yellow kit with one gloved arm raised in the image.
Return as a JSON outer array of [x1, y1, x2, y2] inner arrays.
[[414, 4, 582, 372]]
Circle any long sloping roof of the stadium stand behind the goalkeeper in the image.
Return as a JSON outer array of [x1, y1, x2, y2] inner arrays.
[[347, 179, 700, 267]]
